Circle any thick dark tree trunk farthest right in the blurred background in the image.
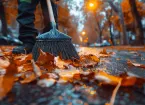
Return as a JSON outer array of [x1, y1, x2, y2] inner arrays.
[[129, 0, 144, 45]]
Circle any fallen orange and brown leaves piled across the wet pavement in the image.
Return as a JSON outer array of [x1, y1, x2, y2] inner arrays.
[[0, 47, 145, 105]]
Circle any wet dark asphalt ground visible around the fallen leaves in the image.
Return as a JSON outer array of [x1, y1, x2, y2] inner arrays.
[[0, 48, 145, 105]]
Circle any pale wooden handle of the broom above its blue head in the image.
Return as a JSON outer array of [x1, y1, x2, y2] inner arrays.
[[46, 0, 56, 24]]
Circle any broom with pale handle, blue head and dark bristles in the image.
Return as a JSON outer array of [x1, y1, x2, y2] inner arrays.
[[32, 0, 79, 61]]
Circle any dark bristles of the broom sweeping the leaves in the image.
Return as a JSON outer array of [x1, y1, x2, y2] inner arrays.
[[32, 40, 79, 61]]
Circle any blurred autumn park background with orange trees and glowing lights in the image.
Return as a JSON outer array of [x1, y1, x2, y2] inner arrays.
[[0, 0, 145, 47]]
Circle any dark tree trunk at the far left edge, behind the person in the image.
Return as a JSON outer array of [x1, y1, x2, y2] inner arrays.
[[0, 1, 8, 36]]
